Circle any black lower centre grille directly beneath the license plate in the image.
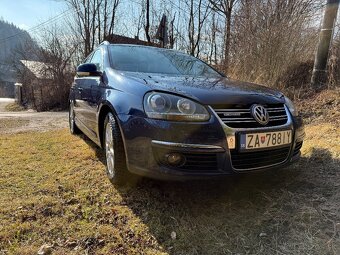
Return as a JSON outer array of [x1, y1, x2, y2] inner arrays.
[[230, 147, 290, 170]]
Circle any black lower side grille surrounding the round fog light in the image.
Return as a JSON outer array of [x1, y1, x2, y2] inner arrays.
[[154, 148, 223, 173]]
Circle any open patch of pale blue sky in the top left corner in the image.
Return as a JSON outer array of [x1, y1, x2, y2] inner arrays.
[[0, 0, 67, 30]]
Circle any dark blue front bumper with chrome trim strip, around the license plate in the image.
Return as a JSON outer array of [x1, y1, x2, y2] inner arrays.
[[118, 108, 304, 180]]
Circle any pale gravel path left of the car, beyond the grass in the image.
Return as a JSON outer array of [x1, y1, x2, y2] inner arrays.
[[0, 98, 68, 134]]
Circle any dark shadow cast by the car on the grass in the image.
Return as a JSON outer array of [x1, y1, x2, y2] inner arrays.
[[81, 134, 340, 254]]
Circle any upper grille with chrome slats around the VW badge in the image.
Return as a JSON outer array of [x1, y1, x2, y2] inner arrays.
[[214, 104, 288, 128]]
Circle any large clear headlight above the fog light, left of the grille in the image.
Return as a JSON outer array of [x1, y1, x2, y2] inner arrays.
[[144, 92, 210, 121]]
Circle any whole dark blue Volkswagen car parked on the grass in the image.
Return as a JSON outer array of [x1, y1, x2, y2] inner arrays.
[[69, 42, 304, 184]]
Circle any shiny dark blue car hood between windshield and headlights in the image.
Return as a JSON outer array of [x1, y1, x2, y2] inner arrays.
[[124, 73, 284, 105]]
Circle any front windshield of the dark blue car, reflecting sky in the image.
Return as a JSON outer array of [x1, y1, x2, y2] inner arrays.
[[109, 45, 221, 77]]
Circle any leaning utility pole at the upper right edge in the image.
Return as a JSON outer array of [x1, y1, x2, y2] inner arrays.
[[311, 0, 340, 90]]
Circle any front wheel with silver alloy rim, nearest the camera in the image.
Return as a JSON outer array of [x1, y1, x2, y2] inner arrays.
[[103, 113, 133, 185]]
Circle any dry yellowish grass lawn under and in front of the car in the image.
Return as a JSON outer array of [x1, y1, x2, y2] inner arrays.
[[0, 124, 340, 255]]
